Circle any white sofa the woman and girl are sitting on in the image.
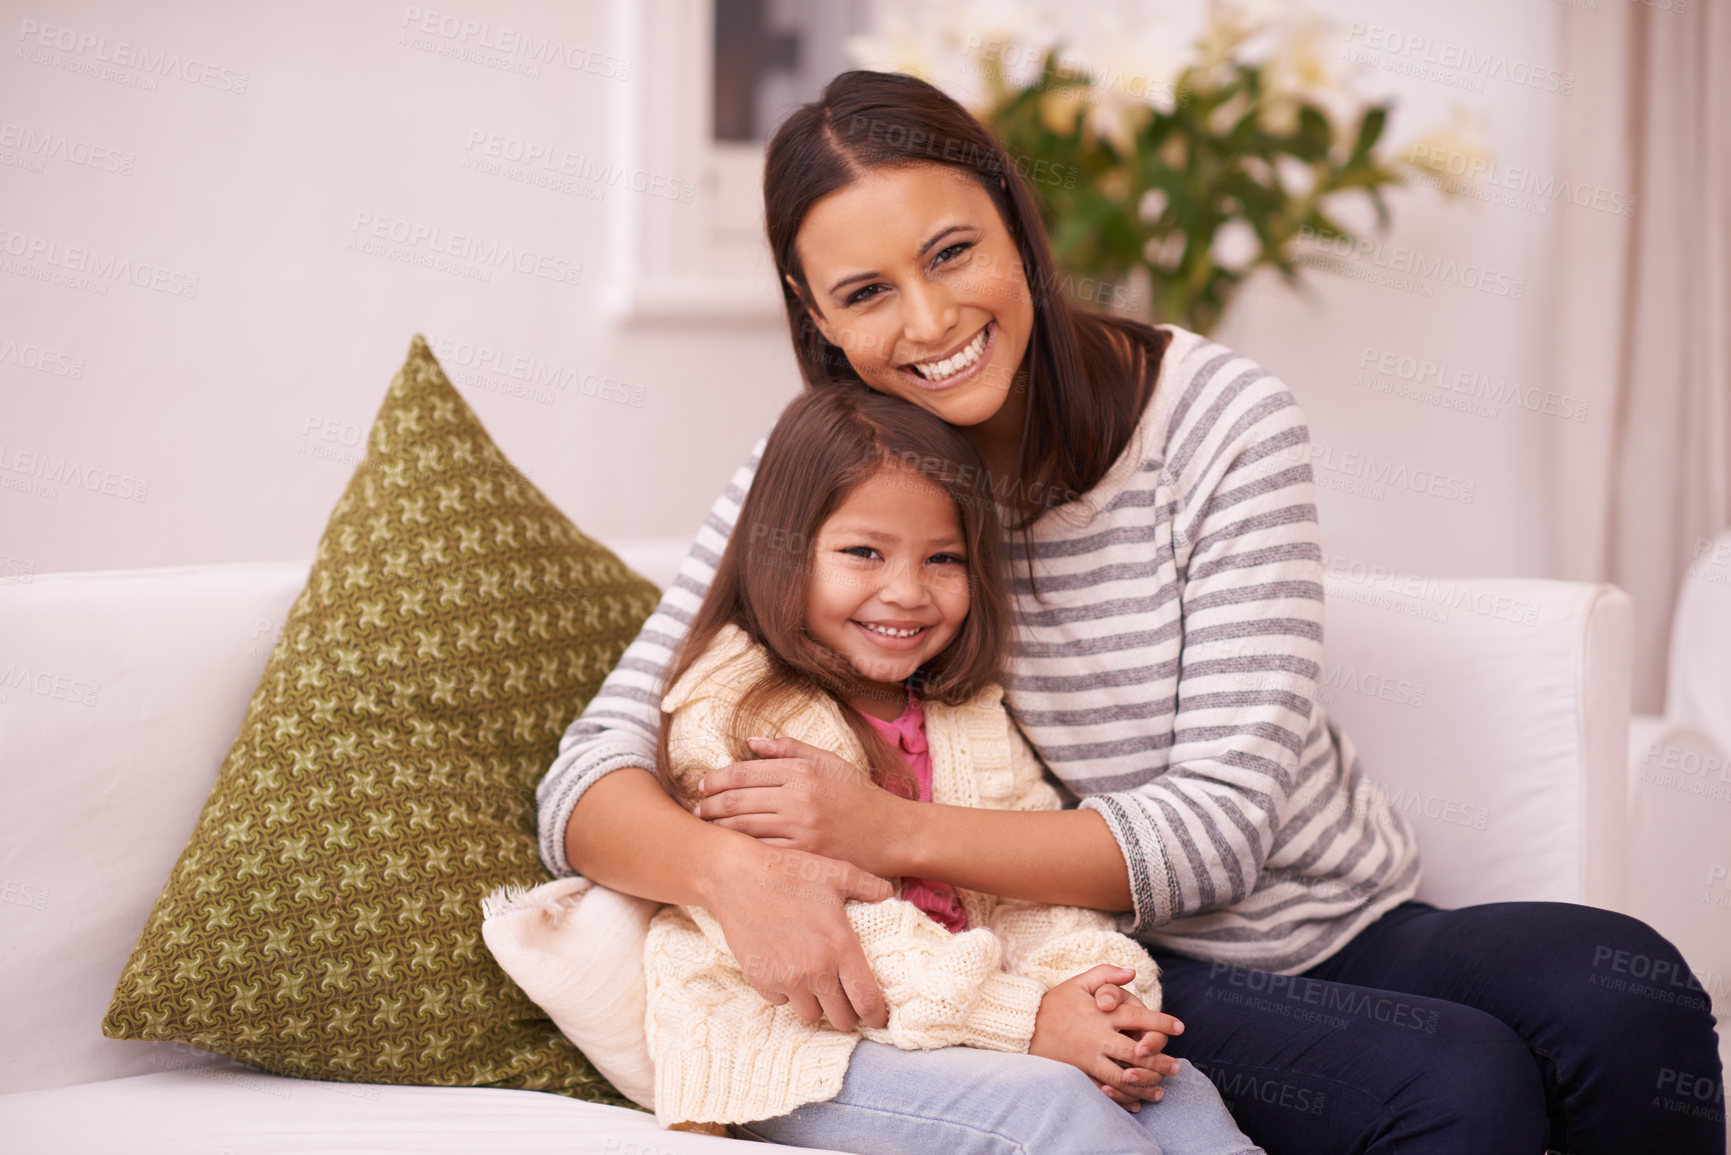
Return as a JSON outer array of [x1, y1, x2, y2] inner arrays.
[[0, 540, 1717, 1155]]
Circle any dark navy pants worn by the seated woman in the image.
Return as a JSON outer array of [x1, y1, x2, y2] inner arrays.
[[1155, 902, 1726, 1155]]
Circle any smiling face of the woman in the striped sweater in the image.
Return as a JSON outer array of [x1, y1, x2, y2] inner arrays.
[[795, 165, 1033, 426]]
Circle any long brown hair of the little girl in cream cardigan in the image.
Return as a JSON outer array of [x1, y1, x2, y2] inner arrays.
[[656, 384, 1013, 809]]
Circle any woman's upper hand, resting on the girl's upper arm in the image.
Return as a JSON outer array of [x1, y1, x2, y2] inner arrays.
[[696, 738, 905, 878]]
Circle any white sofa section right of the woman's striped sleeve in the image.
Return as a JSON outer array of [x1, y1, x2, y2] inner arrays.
[[1321, 565, 1634, 909]]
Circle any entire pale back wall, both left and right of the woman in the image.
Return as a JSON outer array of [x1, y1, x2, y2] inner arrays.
[[0, 0, 1605, 588]]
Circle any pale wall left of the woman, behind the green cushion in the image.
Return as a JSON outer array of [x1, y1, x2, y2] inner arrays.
[[0, 0, 798, 573]]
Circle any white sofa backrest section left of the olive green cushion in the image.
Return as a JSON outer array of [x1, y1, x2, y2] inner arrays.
[[0, 563, 308, 1093]]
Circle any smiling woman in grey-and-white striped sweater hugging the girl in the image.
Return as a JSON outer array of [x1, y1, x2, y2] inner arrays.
[[540, 73, 1724, 1155]]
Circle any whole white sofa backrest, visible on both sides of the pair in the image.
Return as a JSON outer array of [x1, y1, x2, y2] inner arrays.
[[0, 542, 1629, 1093]]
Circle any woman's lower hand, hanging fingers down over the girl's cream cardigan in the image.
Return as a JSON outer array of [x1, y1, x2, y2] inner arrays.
[[706, 840, 895, 1030]]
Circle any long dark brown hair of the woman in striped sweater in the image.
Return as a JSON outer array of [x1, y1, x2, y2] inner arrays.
[[763, 71, 1168, 554]]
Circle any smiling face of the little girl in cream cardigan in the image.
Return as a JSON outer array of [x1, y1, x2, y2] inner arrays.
[[805, 468, 968, 719]]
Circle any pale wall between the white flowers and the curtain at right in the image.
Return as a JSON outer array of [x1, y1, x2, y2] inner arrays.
[[1219, 0, 1571, 577]]
